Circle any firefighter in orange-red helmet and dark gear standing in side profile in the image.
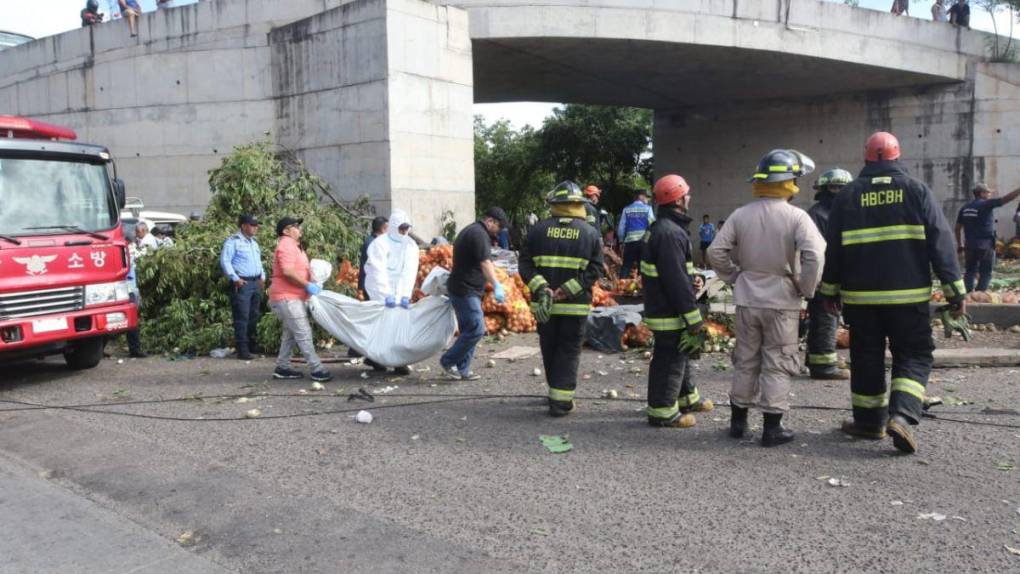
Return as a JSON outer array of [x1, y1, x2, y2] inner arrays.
[[640, 174, 713, 428]]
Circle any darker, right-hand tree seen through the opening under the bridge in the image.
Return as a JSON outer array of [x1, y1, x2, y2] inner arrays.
[[539, 104, 652, 212]]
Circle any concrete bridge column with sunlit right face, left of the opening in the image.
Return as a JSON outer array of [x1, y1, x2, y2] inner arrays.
[[270, 0, 474, 238]]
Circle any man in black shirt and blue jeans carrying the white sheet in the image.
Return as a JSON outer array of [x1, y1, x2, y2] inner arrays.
[[440, 207, 510, 380]]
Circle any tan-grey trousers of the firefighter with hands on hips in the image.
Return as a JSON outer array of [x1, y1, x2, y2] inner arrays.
[[729, 307, 801, 414]]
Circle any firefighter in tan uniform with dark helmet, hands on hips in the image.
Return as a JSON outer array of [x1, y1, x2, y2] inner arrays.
[[708, 150, 825, 447]]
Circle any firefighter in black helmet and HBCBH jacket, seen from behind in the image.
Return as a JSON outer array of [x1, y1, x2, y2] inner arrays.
[[519, 181, 602, 417]]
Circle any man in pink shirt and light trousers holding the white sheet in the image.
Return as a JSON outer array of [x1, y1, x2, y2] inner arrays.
[[269, 217, 333, 382]]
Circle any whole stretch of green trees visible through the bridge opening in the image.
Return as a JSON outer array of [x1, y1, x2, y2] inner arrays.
[[474, 104, 652, 221]]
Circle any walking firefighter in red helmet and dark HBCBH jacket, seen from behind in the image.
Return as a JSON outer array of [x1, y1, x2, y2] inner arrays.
[[819, 132, 966, 454]]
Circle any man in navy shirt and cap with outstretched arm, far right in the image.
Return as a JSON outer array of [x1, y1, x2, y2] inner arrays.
[[956, 184, 1020, 293]]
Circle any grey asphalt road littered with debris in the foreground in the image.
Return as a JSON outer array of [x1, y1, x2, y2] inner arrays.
[[0, 335, 1020, 573]]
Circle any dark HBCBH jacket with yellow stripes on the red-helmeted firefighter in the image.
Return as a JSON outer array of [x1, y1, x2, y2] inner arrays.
[[818, 161, 965, 305]]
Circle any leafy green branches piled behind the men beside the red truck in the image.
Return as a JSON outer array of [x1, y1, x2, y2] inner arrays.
[[137, 141, 366, 354]]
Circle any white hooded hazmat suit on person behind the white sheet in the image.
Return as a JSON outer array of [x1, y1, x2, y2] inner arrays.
[[365, 210, 418, 304]]
